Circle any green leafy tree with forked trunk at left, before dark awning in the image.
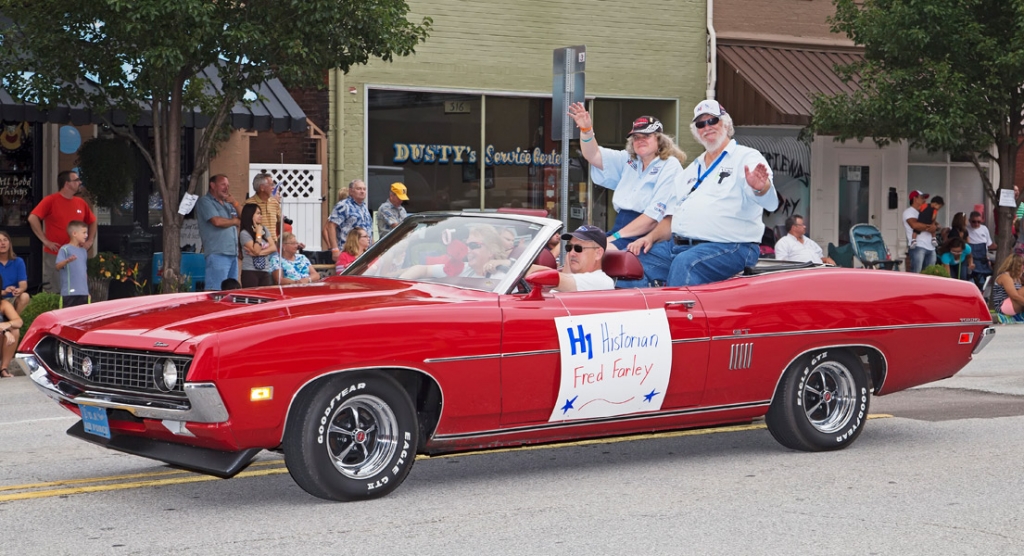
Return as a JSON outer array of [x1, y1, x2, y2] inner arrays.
[[0, 0, 432, 286]]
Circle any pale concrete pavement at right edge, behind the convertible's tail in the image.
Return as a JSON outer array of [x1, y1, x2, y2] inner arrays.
[[919, 325, 1024, 396]]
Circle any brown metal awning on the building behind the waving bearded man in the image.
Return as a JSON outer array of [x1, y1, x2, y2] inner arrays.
[[716, 44, 863, 126]]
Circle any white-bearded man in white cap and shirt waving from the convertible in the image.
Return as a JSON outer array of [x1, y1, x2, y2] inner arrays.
[[618, 100, 778, 287]]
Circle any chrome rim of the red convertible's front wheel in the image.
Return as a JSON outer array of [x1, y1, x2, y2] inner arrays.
[[325, 395, 398, 479]]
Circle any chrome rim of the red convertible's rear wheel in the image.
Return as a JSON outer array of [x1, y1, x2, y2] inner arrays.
[[801, 361, 857, 434]]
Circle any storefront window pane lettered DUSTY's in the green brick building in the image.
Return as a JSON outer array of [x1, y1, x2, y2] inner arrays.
[[367, 90, 479, 212]]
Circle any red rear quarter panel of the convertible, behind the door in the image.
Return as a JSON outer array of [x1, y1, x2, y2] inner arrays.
[[691, 268, 990, 405]]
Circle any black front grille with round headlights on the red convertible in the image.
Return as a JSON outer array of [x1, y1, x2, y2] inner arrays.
[[43, 340, 191, 396]]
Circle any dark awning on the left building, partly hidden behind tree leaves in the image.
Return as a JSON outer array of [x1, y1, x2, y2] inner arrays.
[[0, 66, 306, 133]]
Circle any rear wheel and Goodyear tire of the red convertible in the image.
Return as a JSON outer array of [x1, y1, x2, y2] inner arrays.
[[765, 349, 870, 452]]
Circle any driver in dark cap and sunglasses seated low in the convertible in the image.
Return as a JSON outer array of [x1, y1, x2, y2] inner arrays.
[[527, 225, 615, 292]]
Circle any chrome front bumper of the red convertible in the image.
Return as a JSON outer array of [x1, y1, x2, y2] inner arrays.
[[16, 353, 227, 423]]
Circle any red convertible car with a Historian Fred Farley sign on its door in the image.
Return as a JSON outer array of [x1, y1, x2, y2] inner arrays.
[[18, 213, 994, 501]]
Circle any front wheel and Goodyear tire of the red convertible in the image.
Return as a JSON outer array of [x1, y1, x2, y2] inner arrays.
[[284, 374, 419, 502]]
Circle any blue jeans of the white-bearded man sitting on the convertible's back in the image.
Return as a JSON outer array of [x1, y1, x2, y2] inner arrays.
[[617, 240, 761, 288]]
